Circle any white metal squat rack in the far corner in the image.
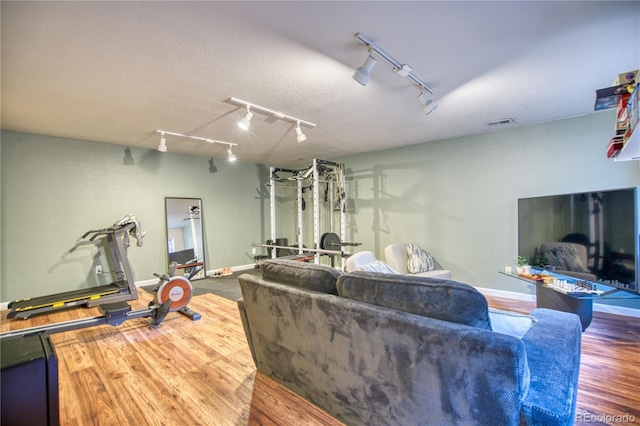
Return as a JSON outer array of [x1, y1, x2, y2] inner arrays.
[[269, 159, 347, 268]]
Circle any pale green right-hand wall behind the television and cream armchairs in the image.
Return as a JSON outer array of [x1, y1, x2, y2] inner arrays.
[[337, 111, 640, 308]]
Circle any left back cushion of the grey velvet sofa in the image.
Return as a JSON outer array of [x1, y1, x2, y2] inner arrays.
[[260, 259, 342, 294]]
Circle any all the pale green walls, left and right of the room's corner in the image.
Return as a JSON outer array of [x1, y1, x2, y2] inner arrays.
[[0, 111, 640, 309]]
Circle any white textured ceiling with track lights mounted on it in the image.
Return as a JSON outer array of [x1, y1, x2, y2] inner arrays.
[[1, 1, 640, 167]]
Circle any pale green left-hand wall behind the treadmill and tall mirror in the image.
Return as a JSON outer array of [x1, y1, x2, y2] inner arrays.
[[0, 131, 269, 302]]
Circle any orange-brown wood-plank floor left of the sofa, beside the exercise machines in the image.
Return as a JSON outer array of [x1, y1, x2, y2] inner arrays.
[[0, 291, 341, 426]]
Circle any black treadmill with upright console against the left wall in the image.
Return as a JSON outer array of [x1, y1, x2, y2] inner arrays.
[[7, 221, 141, 319]]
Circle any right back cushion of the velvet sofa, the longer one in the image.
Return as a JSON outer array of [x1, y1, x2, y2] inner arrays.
[[337, 271, 491, 330]]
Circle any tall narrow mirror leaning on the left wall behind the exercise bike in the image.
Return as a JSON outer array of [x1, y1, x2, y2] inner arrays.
[[165, 197, 207, 280]]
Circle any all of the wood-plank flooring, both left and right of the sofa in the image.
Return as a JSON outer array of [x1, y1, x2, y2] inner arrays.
[[0, 291, 640, 426]]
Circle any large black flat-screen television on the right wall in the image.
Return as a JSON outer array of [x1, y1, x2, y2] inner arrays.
[[518, 187, 640, 293]]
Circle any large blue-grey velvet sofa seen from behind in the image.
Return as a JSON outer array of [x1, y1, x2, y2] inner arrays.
[[238, 259, 581, 425]]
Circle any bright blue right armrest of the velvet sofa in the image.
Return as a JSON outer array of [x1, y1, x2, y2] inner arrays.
[[522, 308, 582, 425]]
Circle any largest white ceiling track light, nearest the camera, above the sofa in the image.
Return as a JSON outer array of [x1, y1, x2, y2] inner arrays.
[[353, 33, 437, 114]]
